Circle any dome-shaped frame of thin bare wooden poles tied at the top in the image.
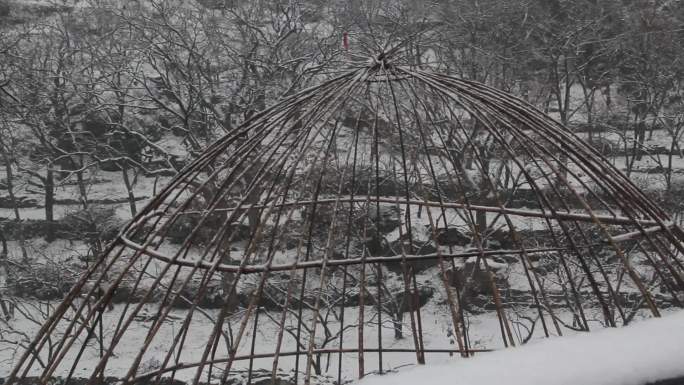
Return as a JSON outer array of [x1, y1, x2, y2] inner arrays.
[[6, 55, 684, 385]]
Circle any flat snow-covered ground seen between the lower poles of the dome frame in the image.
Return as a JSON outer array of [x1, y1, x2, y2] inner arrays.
[[0, 292, 616, 380]]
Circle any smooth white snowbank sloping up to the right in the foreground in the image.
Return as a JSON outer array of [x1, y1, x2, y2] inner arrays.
[[359, 311, 684, 385]]
